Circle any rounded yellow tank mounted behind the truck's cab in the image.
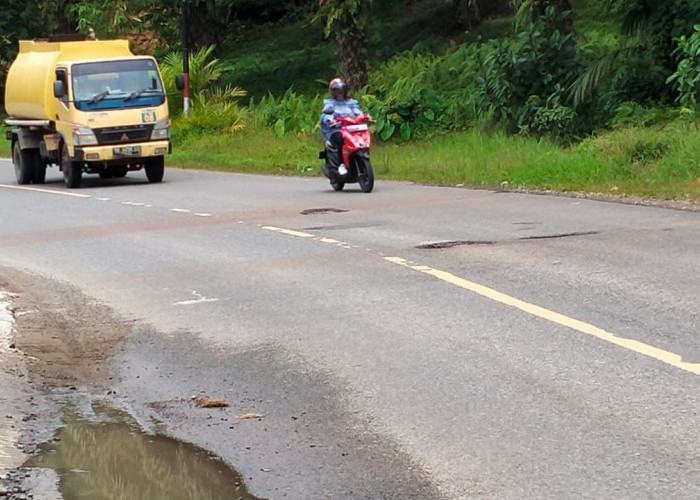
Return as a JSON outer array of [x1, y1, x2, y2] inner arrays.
[[5, 40, 133, 120]]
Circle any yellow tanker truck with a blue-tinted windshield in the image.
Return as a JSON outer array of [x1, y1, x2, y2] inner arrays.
[[5, 34, 171, 188]]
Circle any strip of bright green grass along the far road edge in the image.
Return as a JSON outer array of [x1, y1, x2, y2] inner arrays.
[[168, 115, 700, 200]]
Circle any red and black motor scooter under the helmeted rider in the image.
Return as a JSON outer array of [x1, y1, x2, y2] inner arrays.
[[319, 114, 374, 193]]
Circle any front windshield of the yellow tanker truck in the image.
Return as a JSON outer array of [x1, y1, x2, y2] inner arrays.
[[71, 59, 165, 111]]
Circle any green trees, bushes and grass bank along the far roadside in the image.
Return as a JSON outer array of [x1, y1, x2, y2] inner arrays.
[[0, 0, 700, 200]]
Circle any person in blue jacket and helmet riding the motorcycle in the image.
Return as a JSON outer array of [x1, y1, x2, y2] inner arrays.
[[320, 78, 362, 175]]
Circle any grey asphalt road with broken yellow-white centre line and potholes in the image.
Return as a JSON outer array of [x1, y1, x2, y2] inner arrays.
[[0, 160, 700, 499]]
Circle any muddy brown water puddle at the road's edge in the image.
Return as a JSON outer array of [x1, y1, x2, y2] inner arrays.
[[24, 403, 256, 500]]
